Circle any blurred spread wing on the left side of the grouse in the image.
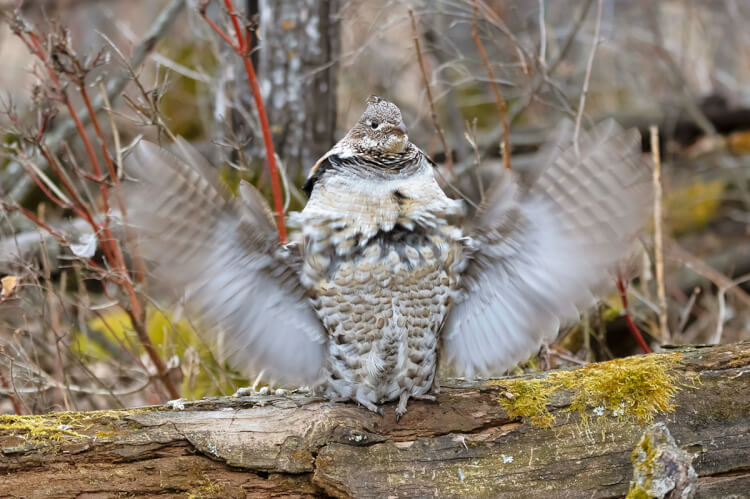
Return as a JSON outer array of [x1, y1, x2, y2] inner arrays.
[[125, 140, 325, 384]]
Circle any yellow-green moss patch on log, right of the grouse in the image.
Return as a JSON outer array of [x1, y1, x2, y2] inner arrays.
[[493, 353, 682, 427]]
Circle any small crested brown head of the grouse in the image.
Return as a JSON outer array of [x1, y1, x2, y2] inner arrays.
[[346, 95, 409, 156]]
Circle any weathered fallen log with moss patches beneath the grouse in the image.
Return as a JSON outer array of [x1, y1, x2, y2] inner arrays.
[[0, 343, 750, 498]]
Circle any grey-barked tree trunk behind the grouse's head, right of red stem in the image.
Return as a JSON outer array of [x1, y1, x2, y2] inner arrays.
[[258, 0, 340, 179]]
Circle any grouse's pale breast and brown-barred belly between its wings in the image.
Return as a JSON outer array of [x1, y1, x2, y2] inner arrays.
[[294, 150, 464, 410]]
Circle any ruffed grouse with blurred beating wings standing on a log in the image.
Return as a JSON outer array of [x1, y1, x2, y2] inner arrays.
[[126, 97, 651, 417]]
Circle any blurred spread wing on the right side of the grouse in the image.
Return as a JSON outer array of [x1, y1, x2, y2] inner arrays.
[[443, 121, 652, 374]]
